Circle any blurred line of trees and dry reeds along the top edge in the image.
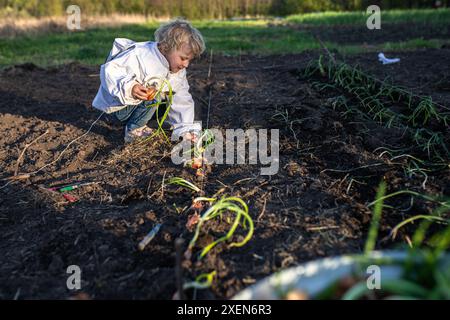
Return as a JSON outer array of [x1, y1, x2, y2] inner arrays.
[[0, 0, 450, 19]]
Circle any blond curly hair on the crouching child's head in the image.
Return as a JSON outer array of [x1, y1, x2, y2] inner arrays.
[[155, 18, 205, 57]]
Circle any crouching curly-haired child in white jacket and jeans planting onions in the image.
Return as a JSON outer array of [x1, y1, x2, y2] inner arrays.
[[92, 19, 205, 143]]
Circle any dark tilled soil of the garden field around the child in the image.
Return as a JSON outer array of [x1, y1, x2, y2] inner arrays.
[[0, 49, 450, 299]]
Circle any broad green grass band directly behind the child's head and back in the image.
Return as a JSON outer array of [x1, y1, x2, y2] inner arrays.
[[0, 21, 319, 67]]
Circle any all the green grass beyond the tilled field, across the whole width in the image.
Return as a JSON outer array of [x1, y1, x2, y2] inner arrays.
[[0, 10, 450, 67]]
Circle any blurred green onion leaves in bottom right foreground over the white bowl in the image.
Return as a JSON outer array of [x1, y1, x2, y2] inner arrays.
[[342, 182, 450, 300]]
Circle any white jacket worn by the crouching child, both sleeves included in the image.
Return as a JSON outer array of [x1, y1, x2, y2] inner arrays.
[[92, 39, 201, 137]]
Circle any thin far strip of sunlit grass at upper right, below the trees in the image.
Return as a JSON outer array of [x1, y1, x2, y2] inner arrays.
[[286, 8, 450, 27]]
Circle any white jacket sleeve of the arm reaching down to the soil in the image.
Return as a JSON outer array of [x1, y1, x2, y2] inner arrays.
[[167, 70, 202, 137]]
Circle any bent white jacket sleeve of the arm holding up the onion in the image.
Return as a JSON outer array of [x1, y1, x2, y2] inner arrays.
[[100, 50, 142, 105]]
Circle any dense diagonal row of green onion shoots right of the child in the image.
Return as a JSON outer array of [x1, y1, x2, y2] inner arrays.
[[303, 56, 450, 161]]
